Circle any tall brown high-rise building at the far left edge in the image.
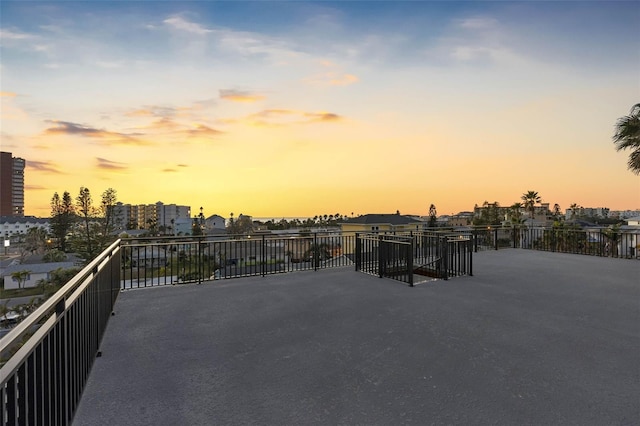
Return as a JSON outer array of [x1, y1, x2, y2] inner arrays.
[[0, 152, 26, 217]]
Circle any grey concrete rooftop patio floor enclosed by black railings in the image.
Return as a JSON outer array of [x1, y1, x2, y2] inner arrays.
[[73, 249, 640, 426]]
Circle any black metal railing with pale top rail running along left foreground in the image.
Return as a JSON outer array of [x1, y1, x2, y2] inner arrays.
[[0, 241, 121, 426]]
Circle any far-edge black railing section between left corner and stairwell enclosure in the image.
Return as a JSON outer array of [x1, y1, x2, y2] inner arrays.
[[121, 233, 355, 288]]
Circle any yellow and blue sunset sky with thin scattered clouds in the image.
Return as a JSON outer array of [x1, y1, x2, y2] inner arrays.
[[0, 1, 640, 217]]
